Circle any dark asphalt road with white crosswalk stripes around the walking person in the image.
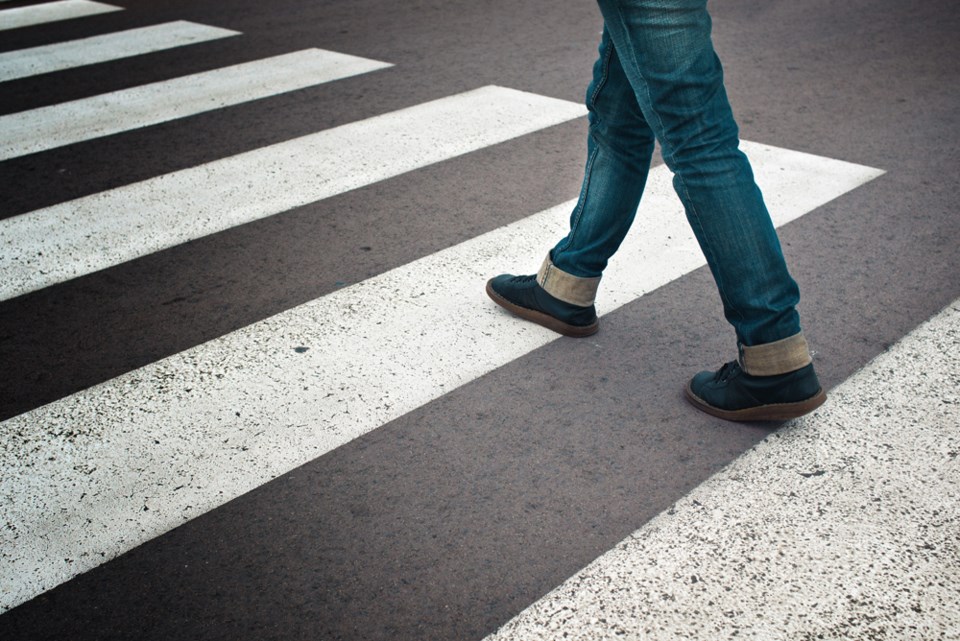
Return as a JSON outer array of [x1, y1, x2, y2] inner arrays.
[[0, 0, 960, 641]]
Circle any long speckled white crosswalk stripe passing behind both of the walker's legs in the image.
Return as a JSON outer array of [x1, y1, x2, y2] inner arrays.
[[0, 144, 882, 607]]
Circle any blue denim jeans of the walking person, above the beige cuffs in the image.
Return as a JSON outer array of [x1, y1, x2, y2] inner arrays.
[[541, 0, 809, 360]]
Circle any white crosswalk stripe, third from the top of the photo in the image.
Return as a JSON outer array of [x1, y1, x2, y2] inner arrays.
[[0, 49, 391, 160]]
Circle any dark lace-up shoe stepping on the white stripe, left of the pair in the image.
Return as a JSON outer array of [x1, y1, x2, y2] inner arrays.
[[487, 274, 600, 338]]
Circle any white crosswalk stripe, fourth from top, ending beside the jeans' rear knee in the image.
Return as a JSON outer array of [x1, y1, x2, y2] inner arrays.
[[0, 87, 585, 299]]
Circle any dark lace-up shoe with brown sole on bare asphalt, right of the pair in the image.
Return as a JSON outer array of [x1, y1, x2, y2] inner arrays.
[[686, 361, 827, 421]]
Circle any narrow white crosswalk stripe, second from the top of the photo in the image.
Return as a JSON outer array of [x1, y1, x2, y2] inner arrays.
[[0, 21, 240, 82]]
